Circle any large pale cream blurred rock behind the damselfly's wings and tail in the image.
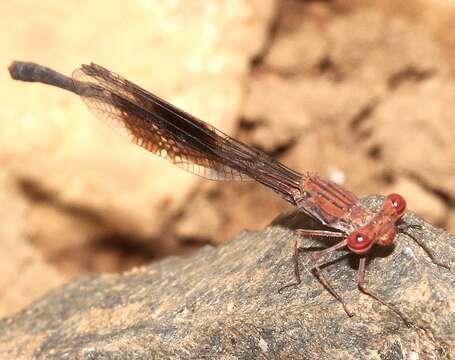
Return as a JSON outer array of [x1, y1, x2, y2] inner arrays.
[[0, 1, 273, 246]]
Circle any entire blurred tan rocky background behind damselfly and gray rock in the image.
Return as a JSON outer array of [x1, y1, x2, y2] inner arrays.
[[0, 0, 455, 317]]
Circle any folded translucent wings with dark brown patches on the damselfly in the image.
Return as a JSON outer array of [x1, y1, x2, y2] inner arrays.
[[73, 64, 301, 203]]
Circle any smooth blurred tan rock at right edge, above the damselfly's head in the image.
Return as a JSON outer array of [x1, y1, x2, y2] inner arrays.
[[368, 77, 455, 199]]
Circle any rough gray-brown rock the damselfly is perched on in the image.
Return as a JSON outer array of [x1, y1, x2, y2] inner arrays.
[[0, 197, 455, 359]]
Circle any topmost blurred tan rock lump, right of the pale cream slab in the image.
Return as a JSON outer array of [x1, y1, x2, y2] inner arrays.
[[265, 6, 449, 84]]
